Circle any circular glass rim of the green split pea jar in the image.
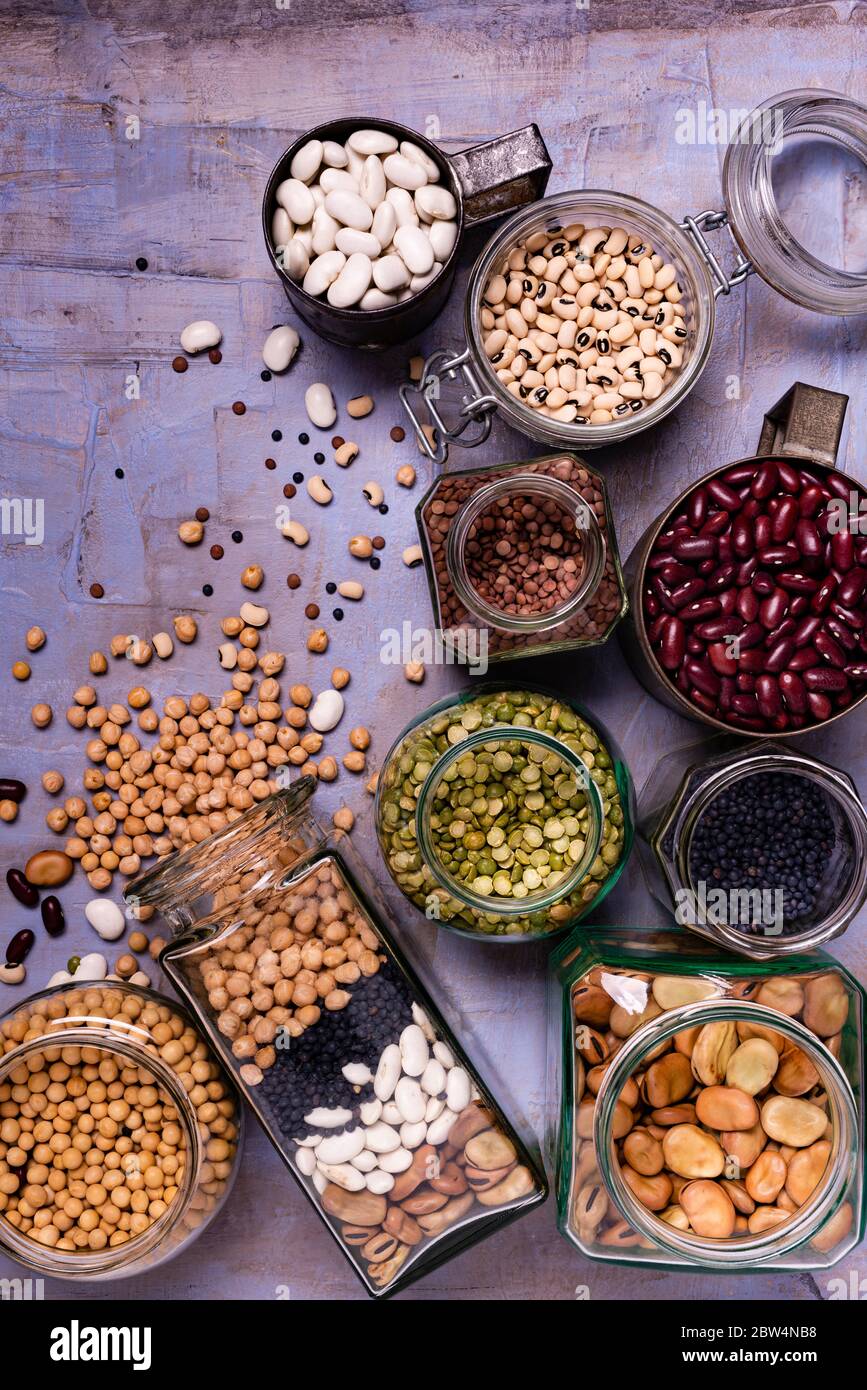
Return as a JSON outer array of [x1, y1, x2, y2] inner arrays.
[[415, 724, 603, 917]]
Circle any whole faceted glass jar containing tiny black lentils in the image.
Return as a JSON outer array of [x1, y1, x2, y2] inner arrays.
[[638, 737, 867, 960]]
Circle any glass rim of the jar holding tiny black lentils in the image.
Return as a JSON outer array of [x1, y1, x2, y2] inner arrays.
[[653, 748, 867, 959]]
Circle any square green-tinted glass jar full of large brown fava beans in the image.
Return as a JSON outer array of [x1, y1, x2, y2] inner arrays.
[[549, 929, 864, 1272]]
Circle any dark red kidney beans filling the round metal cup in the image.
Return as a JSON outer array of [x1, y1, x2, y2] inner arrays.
[[642, 459, 867, 733]]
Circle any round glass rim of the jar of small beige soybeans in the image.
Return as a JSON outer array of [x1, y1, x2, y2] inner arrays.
[[0, 1000, 201, 1280]]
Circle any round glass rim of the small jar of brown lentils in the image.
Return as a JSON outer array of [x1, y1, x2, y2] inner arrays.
[[446, 473, 606, 632]]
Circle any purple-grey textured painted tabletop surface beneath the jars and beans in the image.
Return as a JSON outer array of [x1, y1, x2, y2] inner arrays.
[[0, 0, 867, 1300]]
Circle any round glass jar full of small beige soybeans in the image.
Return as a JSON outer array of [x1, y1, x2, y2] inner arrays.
[[0, 980, 243, 1282]]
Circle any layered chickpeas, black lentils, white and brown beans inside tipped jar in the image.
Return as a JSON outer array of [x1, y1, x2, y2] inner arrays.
[[188, 858, 543, 1291]]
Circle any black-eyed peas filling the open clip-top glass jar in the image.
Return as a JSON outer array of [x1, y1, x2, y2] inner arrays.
[[479, 222, 691, 425]]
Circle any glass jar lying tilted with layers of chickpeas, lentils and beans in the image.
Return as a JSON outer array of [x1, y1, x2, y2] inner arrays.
[[126, 777, 546, 1295]]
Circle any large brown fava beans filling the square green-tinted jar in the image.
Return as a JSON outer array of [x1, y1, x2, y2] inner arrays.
[[570, 966, 860, 1258]]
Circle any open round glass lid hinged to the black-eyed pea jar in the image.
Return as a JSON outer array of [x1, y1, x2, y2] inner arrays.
[[723, 89, 867, 314]]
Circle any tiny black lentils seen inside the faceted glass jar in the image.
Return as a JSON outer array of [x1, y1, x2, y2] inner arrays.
[[689, 773, 838, 934]]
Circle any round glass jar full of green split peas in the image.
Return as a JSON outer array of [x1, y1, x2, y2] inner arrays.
[[375, 684, 634, 941]]
